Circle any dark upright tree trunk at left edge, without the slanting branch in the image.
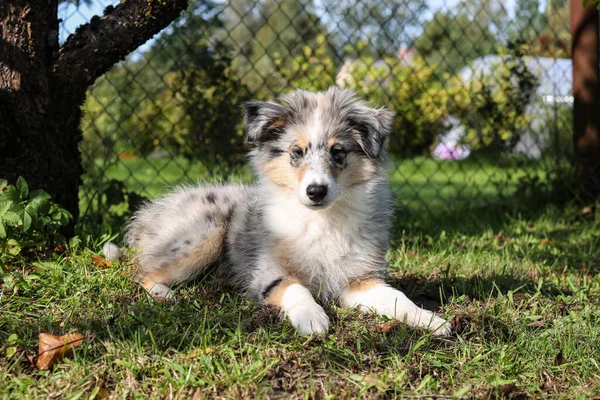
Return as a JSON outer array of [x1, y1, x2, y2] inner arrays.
[[0, 0, 79, 228]]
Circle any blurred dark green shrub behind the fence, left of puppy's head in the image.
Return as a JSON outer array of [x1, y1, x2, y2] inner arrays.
[[81, 46, 250, 163]]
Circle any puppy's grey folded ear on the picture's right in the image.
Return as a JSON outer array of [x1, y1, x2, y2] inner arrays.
[[349, 105, 394, 158]]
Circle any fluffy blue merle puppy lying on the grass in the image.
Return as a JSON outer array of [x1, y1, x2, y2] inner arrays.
[[126, 88, 451, 335]]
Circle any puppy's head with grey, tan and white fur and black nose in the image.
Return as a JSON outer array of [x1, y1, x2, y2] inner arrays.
[[244, 88, 393, 210]]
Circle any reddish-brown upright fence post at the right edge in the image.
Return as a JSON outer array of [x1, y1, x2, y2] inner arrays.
[[571, 0, 600, 200]]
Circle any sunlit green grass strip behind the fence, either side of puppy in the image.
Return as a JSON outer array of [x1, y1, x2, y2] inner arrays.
[[89, 155, 548, 210]]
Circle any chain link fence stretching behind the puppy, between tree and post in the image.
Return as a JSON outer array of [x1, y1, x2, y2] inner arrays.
[[60, 0, 573, 230]]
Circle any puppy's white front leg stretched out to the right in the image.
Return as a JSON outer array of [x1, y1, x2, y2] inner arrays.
[[340, 279, 451, 336]]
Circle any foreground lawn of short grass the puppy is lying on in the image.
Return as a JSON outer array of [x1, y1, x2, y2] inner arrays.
[[0, 158, 600, 399]]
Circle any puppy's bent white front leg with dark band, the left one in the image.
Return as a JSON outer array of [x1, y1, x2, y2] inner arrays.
[[261, 278, 329, 335]]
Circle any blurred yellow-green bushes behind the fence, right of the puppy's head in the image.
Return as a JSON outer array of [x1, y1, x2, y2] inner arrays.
[[276, 37, 537, 156]]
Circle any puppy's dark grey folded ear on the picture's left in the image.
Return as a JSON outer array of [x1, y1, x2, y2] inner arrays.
[[242, 100, 290, 143]]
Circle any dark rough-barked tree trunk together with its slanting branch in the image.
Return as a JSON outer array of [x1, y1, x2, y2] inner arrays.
[[0, 0, 187, 233]]
